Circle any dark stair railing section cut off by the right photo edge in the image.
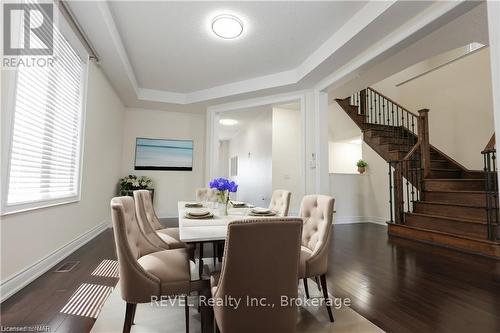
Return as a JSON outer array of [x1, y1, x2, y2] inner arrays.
[[481, 137, 500, 241]]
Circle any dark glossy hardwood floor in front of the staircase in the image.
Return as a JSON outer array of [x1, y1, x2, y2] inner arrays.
[[328, 223, 500, 333]]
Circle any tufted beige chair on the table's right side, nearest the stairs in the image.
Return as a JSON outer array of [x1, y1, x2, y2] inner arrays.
[[299, 195, 335, 322]]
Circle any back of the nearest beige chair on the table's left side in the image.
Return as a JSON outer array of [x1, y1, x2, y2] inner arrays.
[[111, 197, 162, 303]]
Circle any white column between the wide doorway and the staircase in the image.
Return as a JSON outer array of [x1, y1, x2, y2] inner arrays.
[[314, 90, 330, 194]]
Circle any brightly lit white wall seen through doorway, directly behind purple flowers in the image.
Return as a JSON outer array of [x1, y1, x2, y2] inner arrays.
[[229, 107, 272, 206]]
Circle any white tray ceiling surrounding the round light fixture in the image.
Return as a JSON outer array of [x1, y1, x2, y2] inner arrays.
[[68, 0, 480, 108]]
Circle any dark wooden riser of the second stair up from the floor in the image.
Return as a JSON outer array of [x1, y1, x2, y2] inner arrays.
[[405, 214, 488, 240]]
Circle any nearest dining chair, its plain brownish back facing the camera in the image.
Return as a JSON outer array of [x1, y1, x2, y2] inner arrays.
[[211, 218, 302, 333]]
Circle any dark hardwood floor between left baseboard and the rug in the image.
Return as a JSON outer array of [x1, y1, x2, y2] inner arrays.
[[0, 229, 117, 332]]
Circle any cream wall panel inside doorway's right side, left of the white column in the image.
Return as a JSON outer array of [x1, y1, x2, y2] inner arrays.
[[272, 107, 303, 215]]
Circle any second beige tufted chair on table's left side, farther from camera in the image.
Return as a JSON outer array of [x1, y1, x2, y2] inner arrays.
[[134, 190, 186, 249]]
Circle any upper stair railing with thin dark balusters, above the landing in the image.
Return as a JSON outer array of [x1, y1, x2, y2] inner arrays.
[[350, 88, 419, 151]]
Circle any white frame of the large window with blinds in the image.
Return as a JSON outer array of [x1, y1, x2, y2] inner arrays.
[[0, 7, 90, 216]]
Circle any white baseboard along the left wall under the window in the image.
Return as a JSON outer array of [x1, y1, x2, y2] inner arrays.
[[0, 221, 111, 302]]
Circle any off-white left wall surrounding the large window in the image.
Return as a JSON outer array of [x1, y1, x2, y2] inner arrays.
[[0, 63, 124, 282]]
